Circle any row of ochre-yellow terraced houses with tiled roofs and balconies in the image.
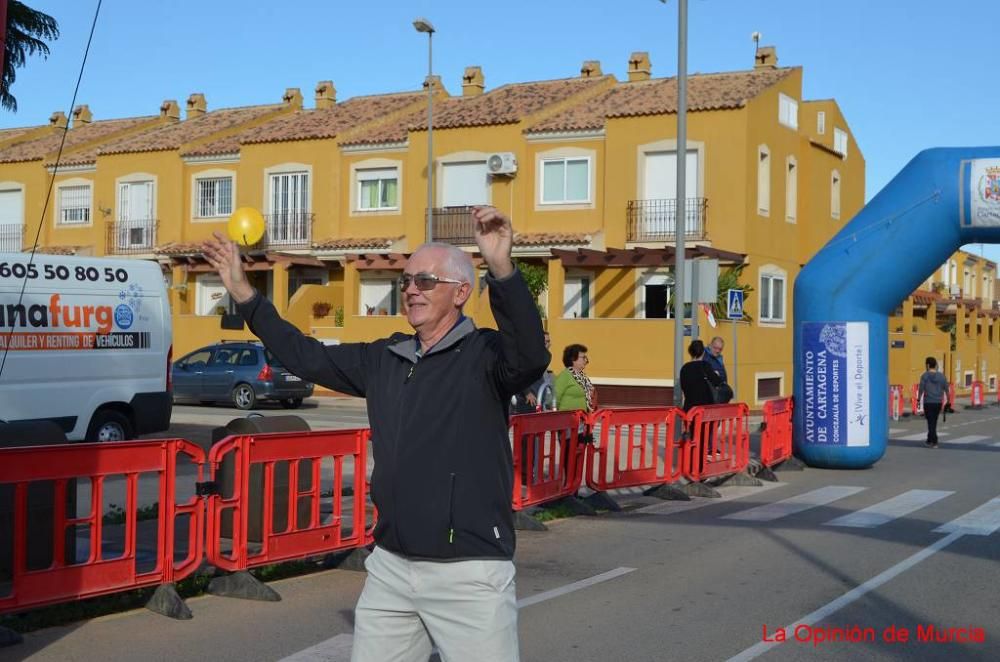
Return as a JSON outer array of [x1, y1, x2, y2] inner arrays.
[[0, 48, 865, 407]]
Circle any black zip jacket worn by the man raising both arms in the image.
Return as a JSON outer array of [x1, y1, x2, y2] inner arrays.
[[239, 272, 550, 561]]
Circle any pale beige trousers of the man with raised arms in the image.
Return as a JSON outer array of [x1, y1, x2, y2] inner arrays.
[[351, 547, 519, 662]]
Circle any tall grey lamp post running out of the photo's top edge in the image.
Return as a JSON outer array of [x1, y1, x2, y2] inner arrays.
[[660, 0, 698, 407]]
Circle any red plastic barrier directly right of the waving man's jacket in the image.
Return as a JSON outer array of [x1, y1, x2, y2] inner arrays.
[[511, 411, 586, 510]]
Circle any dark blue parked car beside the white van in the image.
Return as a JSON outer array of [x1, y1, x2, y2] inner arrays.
[[172, 342, 313, 409]]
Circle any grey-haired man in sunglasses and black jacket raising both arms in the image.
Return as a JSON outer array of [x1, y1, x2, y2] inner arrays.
[[204, 207, 550, 662]]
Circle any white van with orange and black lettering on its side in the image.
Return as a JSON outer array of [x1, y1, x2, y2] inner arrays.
[[0, 253, 173, 441]]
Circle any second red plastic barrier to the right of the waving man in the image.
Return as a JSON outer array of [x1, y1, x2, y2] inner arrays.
[[585, 407, 687, 492]]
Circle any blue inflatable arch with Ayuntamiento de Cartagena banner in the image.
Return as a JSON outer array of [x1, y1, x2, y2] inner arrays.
[[793, 147, 1000, 469]]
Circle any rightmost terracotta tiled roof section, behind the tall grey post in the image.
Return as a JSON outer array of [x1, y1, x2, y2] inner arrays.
[[527, 68, 795, 133]]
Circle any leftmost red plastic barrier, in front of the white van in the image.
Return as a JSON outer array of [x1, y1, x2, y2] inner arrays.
[[0, 439, 205, 612]]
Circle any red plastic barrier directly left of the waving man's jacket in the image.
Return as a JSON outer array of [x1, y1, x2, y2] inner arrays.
[[206, 429, 371, 570]]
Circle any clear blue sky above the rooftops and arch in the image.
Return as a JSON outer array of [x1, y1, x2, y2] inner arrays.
[[0, 0, 1000, 259]]
